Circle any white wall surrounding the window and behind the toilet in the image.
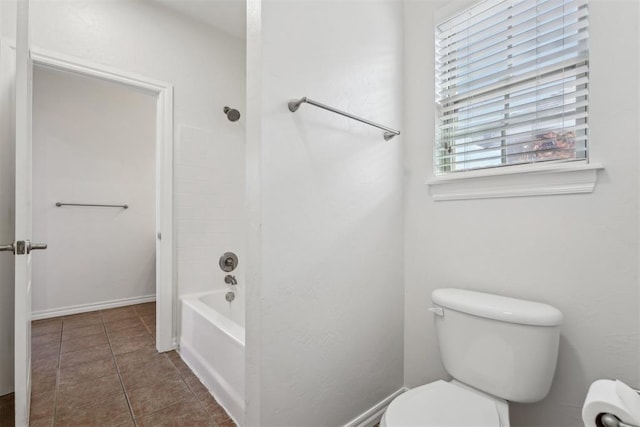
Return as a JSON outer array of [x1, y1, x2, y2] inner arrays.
[[404, 0, 640, 426]]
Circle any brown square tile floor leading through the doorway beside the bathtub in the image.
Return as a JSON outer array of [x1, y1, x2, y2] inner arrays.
[[23, 303, 235, 427]]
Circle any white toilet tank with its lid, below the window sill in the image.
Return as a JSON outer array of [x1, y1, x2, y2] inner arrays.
[[431, 288, 562, 403]]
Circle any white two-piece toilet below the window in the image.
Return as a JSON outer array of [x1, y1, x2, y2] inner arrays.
[[380, 288, 562, 427]]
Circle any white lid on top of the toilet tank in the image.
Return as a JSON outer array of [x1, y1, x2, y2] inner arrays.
[[431, 288, 562, 326]]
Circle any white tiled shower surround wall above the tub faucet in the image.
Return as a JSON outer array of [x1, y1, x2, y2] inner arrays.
[[176, 124, 247, 300]]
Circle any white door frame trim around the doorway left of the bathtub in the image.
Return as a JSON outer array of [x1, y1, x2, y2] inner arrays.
[[31, 47, 177, 352]]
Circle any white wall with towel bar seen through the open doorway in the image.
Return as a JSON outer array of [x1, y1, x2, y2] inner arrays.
[[32, 67, 157, 313]]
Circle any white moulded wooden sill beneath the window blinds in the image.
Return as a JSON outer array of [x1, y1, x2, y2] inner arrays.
[[427, 162, 604, 201]]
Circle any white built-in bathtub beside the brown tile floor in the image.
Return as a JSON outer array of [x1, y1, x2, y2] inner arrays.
[[180, 289, 244, 425]]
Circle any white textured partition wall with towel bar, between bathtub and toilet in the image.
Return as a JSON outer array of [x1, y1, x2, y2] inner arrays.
[[247, 0, 403, 426]]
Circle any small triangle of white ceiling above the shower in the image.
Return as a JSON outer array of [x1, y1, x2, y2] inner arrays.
[[155, 0, 247, 39]]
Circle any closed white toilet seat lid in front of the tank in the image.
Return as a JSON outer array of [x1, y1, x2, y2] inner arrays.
[[381, 381, 501, 427]]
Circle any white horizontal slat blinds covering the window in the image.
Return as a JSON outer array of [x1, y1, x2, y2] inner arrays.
[[434, 0, 589, 174]]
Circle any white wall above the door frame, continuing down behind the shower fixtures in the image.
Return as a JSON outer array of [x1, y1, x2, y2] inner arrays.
[[25, 0, 245, 304]]
